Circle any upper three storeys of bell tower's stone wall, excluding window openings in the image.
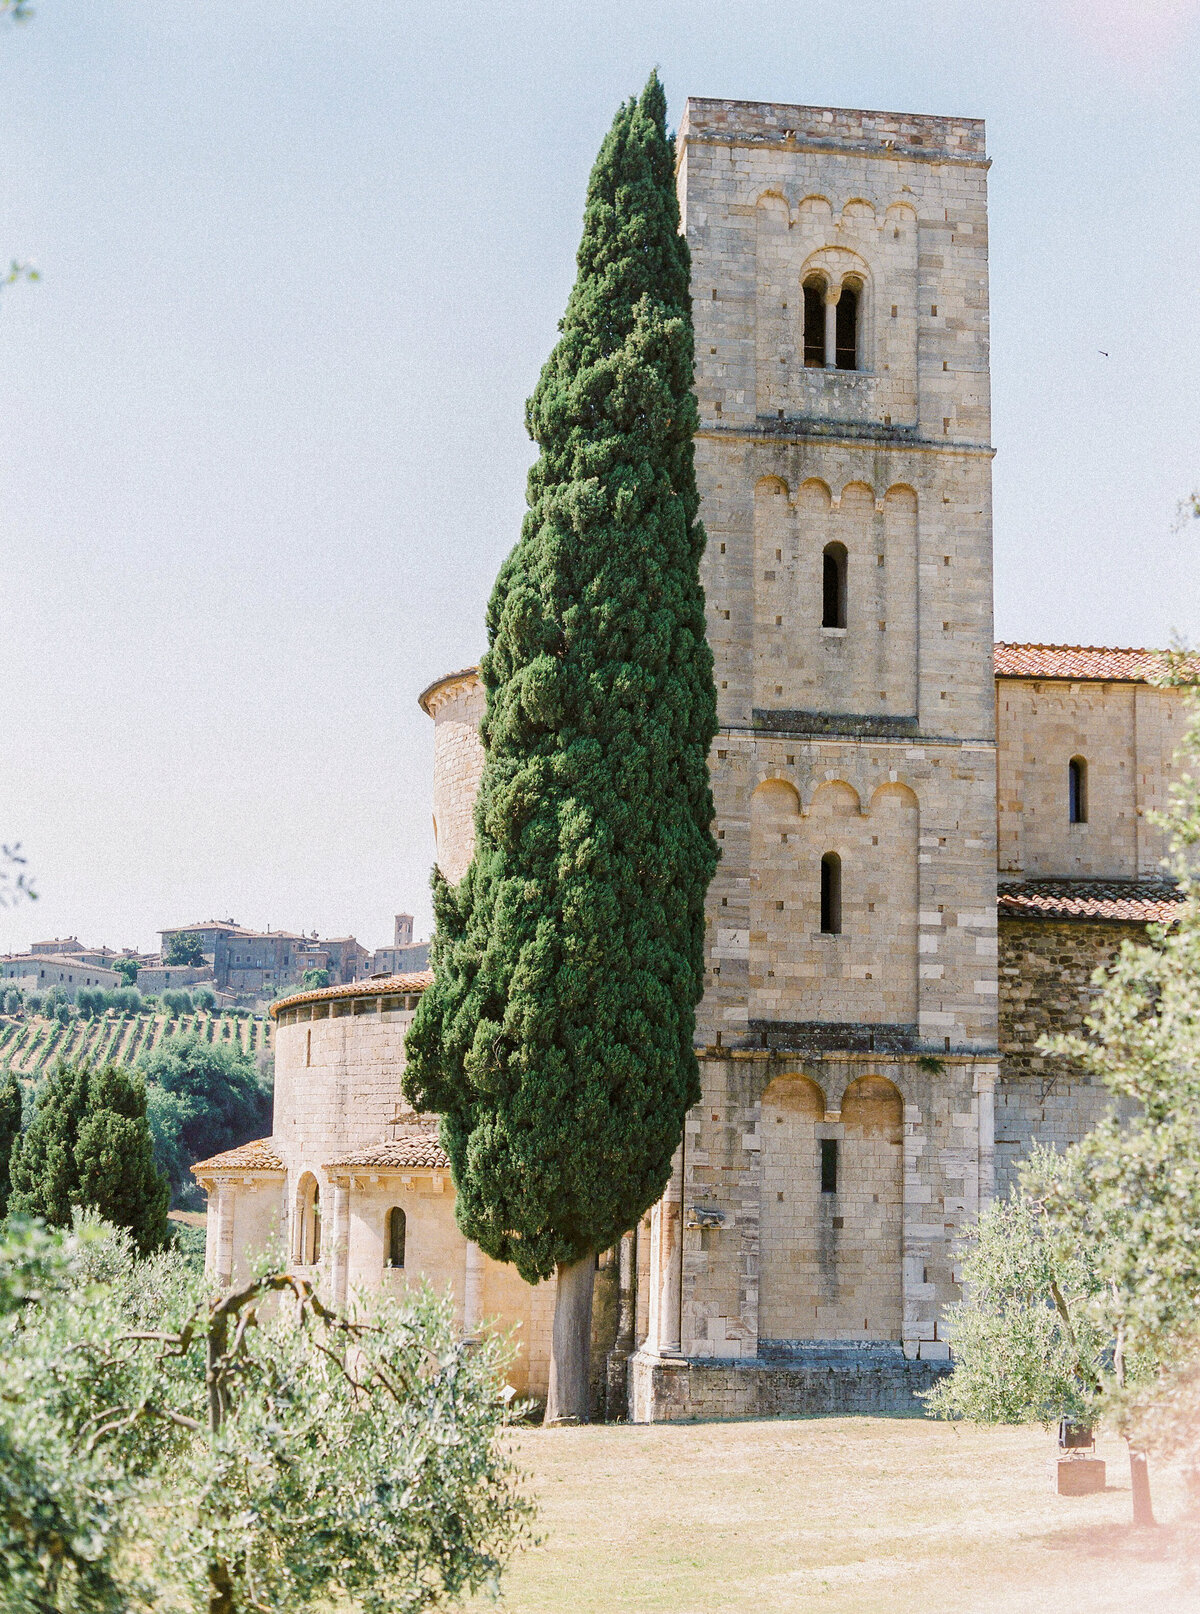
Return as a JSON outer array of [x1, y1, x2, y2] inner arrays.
[[678, 100, 995, 1052]]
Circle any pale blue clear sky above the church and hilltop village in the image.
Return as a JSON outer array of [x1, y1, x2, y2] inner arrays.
[[0, 0, 1200, 949]]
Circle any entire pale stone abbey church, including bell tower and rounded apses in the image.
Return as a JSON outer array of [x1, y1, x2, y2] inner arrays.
[[197, 100, 1184, 1420]]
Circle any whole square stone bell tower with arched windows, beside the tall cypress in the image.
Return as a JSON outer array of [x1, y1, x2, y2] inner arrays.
[[631, 100, 997, 1419]]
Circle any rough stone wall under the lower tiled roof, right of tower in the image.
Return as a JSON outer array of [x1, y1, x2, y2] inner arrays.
[[995, 918, 1143, 1194]]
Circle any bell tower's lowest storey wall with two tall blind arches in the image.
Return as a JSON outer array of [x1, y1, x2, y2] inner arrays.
[[683, 1049, 995, 1361]]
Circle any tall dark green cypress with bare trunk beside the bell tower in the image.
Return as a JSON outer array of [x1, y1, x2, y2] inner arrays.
[[405, 74, 717, 1420]]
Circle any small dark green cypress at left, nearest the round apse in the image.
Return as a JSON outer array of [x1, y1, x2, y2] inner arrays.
[[74, 1065, 171, 1256]]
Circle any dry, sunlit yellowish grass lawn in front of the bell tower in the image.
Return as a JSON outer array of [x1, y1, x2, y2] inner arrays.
[[470, 1417, 1200, 1614]]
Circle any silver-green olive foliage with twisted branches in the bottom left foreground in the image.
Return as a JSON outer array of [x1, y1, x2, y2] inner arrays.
[[0, 1222, 530, 1614]]
